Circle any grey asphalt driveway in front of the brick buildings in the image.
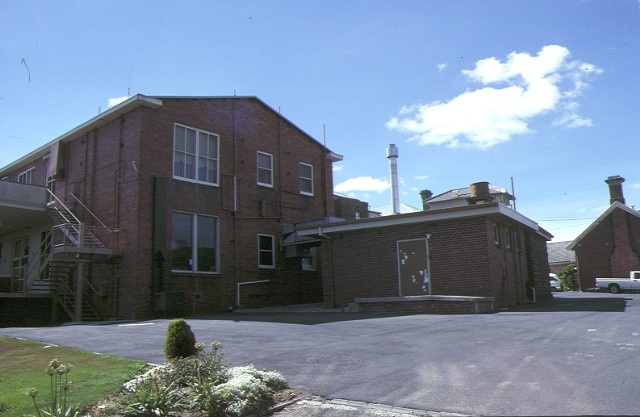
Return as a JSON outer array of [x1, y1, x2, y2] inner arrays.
[[0, 293, 640, 415]]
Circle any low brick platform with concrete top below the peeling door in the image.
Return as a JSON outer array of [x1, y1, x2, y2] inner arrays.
[[349, 295, 495, 314]]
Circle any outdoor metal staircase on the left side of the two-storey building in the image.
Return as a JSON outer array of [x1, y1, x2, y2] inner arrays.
[[25, 194, 116, 321]]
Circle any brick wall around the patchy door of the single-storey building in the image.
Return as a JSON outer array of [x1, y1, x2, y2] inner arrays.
[[322, 217, 536, 307]]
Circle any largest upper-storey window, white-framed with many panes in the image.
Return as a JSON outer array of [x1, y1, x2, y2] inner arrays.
[[173, 124, 220, 185]]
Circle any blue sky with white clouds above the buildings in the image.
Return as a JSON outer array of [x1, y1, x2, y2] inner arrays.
[[0, 0, 640, 240]]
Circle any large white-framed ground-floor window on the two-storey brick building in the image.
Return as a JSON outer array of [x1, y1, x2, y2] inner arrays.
[[171, 213, 219, 273]]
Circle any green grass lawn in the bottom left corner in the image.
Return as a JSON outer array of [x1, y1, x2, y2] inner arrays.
[[0, 336, 147, 417]]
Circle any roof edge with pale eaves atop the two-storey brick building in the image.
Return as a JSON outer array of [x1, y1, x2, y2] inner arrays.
[[0, 94, 342, 177]]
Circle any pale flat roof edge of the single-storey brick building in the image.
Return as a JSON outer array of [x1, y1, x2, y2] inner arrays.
[[298, 202, 553, 240]]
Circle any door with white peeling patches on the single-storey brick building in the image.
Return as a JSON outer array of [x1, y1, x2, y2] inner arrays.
[[397, 238, 431, 296]]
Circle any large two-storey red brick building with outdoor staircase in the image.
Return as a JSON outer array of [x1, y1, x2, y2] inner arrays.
[[0, 95, 341, 322]]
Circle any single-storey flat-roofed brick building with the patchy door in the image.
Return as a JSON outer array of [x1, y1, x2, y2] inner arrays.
[[298, 183, 552, 312]]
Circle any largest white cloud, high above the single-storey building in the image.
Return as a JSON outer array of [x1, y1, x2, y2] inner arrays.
[[387, 45, 602, 149]]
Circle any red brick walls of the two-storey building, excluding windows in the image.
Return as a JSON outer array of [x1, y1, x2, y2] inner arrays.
[[2, 98, 333, 319]]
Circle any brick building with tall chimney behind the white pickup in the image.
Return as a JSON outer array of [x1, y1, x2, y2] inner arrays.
[[567, 175, 640, 291]]
